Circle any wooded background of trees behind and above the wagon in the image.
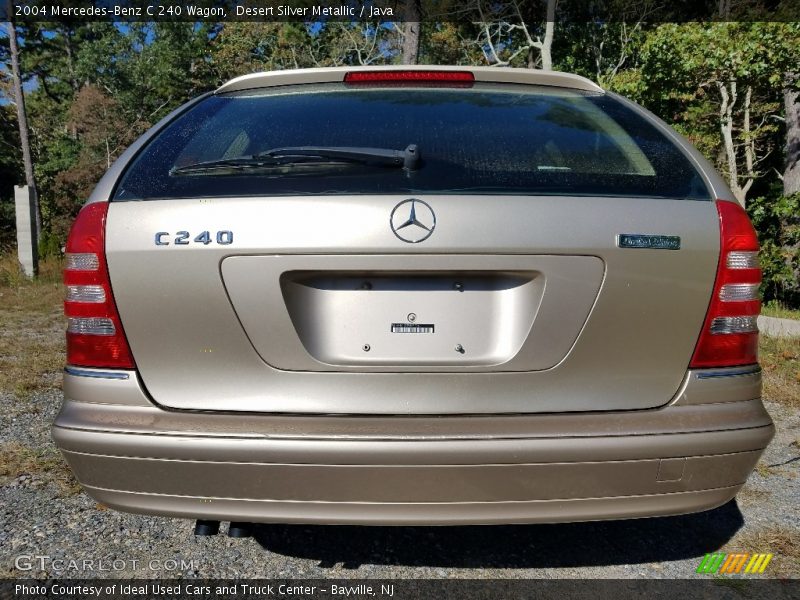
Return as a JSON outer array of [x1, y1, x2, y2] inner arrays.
[[0, 0, 800, 308]]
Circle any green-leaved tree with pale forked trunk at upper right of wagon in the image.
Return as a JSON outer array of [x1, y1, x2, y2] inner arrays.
[[642, 23, 780, 206]]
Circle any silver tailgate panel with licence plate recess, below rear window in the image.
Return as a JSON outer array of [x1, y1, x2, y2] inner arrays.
[[106, 195, 719, 414]]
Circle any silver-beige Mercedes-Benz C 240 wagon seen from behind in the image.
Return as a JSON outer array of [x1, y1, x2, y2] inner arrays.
[[53, 67, 774, 524]]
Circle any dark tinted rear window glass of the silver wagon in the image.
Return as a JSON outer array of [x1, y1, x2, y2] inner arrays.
[[114, 84, 709, 200]]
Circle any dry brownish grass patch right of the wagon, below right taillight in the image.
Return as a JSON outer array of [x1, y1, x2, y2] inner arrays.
[[758, 335, 800, 408]]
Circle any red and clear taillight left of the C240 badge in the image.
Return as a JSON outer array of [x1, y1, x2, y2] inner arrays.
[[64, 202, 135, 369]]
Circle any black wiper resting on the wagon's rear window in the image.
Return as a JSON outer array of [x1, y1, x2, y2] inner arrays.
[[169, 144, 420, 175]]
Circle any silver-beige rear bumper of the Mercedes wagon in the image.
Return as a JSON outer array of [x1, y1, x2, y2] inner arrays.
[[53, 364, 774, 524]]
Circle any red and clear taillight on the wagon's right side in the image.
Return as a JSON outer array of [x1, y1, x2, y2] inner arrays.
[[689, 200, 761, 368]]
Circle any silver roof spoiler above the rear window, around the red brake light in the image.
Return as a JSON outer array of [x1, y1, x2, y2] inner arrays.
[[214, 65, 604, 94]]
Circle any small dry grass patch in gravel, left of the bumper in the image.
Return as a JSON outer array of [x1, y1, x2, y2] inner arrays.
[[0, 442, 81, 495]]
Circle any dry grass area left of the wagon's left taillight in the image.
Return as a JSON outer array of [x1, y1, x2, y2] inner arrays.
[[0, 256, 65, 399]]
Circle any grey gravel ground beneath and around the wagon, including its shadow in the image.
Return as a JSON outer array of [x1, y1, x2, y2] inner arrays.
[[0, 391, 800, 579]]
